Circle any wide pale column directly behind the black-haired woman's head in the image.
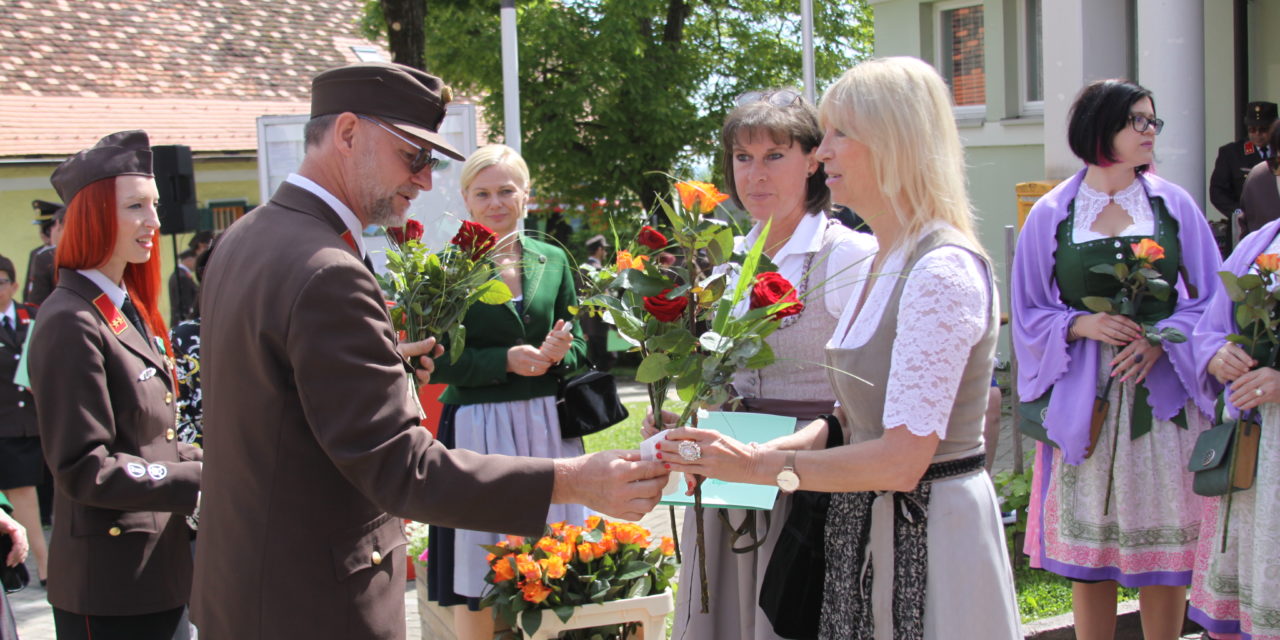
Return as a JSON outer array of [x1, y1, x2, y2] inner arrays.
[[1041, 0, 1129, 179]]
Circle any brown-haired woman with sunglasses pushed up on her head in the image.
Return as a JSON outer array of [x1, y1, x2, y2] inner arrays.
[[644, 88, 876, 640]]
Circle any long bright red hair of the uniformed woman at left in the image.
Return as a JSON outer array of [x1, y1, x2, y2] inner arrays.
[[54, 177, 173, 356]]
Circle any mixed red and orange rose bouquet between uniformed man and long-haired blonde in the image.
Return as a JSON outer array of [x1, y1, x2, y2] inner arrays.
[[581, 182, 804, 613]]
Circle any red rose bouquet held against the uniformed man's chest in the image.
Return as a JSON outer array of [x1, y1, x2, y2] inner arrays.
[[379, 220, 511, 362]]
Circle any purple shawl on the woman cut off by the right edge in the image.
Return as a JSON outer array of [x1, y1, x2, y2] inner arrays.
[[1192, 220, 1280, 419]]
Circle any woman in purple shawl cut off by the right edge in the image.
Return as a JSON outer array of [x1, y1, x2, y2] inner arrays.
[[1190, 220, 1280, 640]]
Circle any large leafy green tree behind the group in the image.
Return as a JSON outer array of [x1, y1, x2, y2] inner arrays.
[[365, 0, 872, 222]]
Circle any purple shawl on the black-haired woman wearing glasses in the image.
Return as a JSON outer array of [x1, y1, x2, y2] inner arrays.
[[1010, 169, 1220, 465]]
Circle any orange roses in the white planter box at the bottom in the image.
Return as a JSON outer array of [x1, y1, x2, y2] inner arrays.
[[481, 516, 676, 637]]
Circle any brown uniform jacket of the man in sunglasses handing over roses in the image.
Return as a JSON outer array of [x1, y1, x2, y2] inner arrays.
[[192, 183, 553, 640]]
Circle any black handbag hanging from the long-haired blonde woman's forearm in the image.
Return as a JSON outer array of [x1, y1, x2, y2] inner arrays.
[[760, 416, 845, 640]]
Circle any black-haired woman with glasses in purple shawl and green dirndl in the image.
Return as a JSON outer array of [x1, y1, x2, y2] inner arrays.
[[1011, 79, 1219, 639]]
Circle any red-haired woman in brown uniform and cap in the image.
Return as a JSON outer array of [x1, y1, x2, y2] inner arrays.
[[29, 131, 201, 640]]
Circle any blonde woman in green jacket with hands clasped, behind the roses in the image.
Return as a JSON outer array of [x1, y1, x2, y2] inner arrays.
[[428, 145, 589, 640]]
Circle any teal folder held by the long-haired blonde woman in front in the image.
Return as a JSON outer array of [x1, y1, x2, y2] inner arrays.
[[660, 411, 796, 509]]
